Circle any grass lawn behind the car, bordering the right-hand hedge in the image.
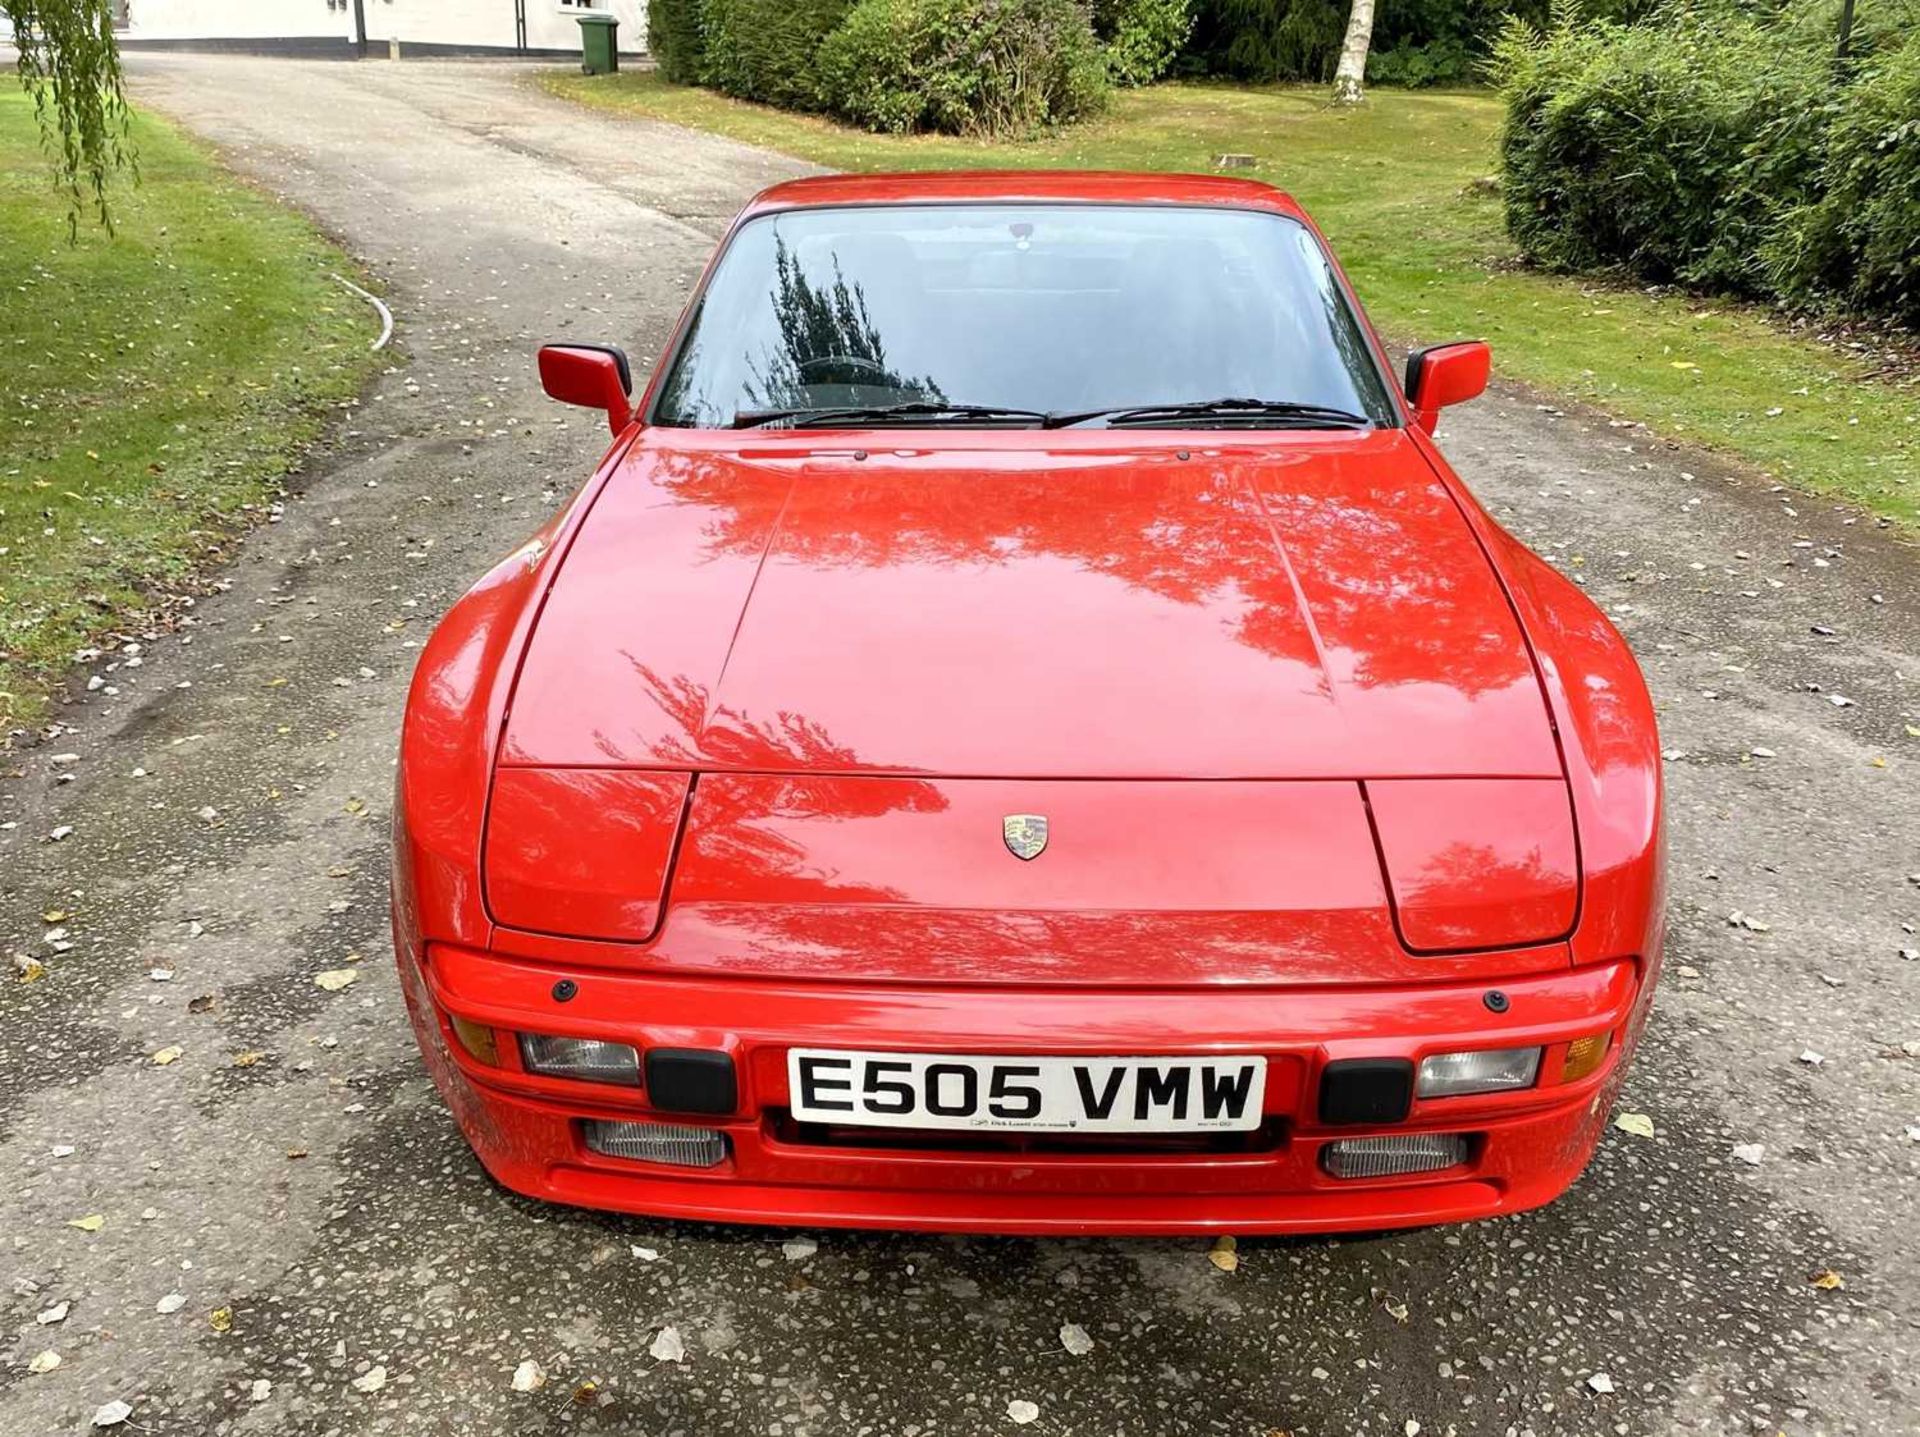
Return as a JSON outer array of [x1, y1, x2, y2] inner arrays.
[[540, 71, 1920, 523]]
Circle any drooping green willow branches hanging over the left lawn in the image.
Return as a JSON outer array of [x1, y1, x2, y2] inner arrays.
[[0, 0, 134, 240]]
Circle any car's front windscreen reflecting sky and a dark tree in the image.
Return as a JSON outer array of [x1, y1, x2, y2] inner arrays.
[[651, 204, 1392, 428]]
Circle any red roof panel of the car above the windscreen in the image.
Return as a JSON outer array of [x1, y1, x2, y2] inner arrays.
[[747, 169, 1306, 219]]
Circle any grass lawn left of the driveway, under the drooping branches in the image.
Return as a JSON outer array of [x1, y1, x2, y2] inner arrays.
[[0, 89, 378, 730]]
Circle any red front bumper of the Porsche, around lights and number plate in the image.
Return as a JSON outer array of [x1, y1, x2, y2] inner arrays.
[[399, 943, 1647, 1235]]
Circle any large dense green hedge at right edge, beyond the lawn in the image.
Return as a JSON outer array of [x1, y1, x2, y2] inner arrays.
[[1492, 4, 1920, 319]]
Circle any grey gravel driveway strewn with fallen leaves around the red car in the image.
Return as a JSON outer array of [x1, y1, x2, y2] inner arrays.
[[0, 56, 1920, 1437]]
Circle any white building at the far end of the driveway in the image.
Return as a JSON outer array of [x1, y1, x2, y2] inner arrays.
[[119, 0, 647, 60]]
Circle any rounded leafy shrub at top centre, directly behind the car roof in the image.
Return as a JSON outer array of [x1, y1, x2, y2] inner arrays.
[[818, 0, 1106, 134]]
